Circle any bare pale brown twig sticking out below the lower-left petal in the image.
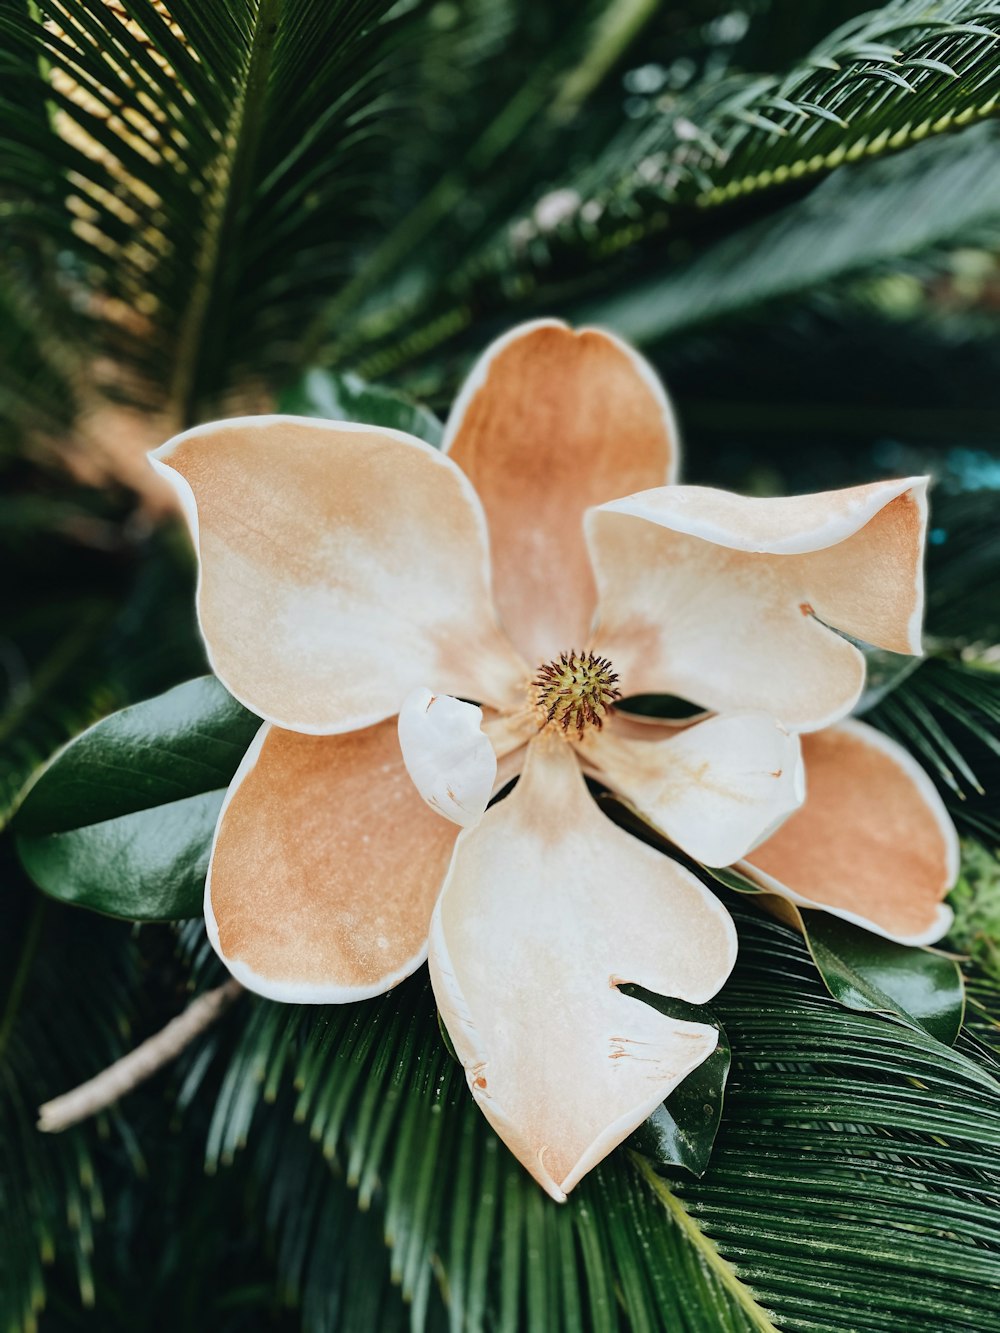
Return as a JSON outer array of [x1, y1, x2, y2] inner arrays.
[[39, 978, 243, 1134]]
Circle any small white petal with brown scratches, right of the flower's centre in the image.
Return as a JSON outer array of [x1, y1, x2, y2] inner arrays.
[[583, 713, 805, 865]]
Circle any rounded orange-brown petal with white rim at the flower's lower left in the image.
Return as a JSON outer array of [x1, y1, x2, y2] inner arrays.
[[205, 718, 457, 1004]]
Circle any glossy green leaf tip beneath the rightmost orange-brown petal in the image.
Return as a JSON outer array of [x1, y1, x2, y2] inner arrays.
[[801, 910, 965, 1045]]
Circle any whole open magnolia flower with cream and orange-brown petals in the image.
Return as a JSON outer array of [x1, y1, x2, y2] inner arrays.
[[152, 321, 953, 1198]]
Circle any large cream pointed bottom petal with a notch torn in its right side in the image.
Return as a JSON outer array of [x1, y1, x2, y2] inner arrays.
[[429, 737, 736, 1200]]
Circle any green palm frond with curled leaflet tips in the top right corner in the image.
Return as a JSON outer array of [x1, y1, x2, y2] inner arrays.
[[581, 0, 1000, 216]]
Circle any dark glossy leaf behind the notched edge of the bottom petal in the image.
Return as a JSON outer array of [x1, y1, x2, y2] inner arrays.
[[621, 986, 732, 1176]]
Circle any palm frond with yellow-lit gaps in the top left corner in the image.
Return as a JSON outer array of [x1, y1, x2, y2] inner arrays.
[[0, 0, 413, 423]]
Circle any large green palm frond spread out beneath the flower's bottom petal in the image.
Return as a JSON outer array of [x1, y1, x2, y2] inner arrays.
[[189, 904, 1000, 1333]]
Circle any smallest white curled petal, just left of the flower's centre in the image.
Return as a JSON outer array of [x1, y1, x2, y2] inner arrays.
[[399, 688, 496, 828]]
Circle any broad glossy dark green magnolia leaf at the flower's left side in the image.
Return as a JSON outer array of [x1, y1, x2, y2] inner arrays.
[[13, 676, 260, 921]]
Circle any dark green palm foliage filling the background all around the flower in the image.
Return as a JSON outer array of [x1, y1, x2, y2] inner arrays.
[[0, 0, 1000, 1333]]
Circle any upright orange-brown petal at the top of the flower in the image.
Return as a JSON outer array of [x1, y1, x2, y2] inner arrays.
[[444, 320, 679, 663]]
